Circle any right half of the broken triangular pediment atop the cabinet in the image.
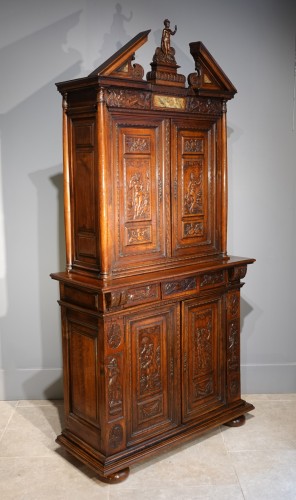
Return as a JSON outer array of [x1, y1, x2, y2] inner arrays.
[[188, 42, 237, 99]]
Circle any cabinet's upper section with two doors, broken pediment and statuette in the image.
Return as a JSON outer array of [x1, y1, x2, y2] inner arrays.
[[57, 19, 236, 279]]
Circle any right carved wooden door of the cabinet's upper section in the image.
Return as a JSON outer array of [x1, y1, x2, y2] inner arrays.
[[172, 120, 218, 257]]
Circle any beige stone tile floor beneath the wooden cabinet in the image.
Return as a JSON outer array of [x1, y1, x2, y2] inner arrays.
[[0, 394, 296, 500]]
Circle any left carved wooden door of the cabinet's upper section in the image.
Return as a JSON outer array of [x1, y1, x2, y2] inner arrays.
[[113, 117, 170, 268]]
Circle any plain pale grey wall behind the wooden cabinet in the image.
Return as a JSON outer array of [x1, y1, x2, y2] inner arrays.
[[0, 0, 296, 399]]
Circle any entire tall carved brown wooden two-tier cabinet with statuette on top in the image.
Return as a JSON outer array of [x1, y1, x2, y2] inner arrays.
[[52, 21, 254, 482]]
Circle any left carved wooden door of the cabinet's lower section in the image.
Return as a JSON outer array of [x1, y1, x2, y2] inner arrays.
[[127, 305, 181, 443]]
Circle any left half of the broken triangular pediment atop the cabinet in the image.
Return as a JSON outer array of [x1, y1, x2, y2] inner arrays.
[[88, 30, 151, 79]]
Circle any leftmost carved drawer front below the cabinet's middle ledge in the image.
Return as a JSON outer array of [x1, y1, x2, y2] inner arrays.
[[105, 283, 160, 310]]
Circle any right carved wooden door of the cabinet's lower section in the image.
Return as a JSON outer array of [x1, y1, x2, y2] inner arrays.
[[182, 297, 224, 422]]
